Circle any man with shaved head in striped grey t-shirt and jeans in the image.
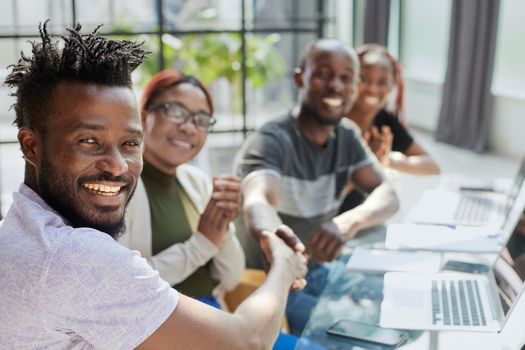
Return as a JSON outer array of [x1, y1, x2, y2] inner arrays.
[[236, 39, 398, 334]]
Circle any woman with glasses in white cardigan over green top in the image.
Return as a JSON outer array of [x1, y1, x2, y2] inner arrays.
[[119, 70, 244, 306]]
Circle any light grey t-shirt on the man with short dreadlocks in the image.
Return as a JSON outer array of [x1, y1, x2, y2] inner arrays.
[[0, 185, 178, 349]]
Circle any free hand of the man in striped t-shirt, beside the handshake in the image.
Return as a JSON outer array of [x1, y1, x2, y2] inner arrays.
[[306, 221, 346, 262]]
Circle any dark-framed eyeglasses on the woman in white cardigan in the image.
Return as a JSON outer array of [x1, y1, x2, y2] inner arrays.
[[148, 101, 217, 131]]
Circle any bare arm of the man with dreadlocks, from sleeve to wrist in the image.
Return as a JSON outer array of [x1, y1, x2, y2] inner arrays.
[[143, 260, 294, 350]]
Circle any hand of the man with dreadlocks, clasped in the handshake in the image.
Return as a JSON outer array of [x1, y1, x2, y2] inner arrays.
[[259, 225, 308, 290]]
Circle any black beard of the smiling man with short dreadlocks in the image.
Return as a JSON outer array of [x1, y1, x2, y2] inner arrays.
[[38, 161, 134, 240]]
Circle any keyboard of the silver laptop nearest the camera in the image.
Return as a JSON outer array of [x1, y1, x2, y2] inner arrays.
[[432, 280, 487, 326]]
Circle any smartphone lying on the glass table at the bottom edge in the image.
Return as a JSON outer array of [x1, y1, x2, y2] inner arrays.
[[326, 319, 408, 347]]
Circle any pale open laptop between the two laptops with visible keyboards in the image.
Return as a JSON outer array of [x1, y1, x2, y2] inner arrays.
[[385, 176, 525, 254]]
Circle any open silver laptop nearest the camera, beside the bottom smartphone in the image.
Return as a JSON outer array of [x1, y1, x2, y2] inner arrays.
[[379, 228, 525, 332]]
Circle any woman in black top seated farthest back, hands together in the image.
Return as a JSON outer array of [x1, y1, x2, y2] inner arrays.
[[348, 45, 439, 175]]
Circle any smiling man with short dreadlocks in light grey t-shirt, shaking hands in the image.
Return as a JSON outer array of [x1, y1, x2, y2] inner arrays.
[[0, 24, 306, 349]]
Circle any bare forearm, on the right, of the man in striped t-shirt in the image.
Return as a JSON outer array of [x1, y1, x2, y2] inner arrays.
[[333, 181, 399, 238]]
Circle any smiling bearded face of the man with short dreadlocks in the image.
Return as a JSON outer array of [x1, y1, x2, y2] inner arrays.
[[35, 82, 143, 237]]
